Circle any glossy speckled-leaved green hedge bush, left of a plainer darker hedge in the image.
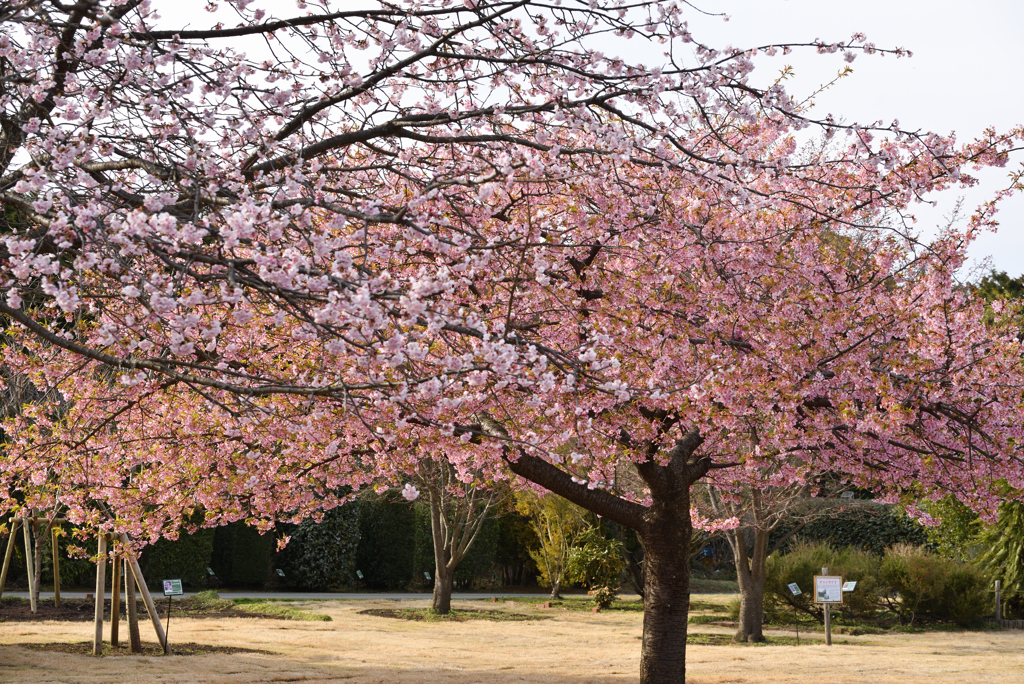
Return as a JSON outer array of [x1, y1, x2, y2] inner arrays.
[[274, 501, 359, 592]]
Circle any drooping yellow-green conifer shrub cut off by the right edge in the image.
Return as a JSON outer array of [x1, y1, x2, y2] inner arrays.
[[977, 501, 1024, 617]]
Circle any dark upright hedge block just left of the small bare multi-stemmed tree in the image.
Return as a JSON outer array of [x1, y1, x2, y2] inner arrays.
[[355, 491, 416, 590]]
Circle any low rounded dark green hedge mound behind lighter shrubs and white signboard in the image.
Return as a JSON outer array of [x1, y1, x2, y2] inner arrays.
[[768, 502, 928, 557]]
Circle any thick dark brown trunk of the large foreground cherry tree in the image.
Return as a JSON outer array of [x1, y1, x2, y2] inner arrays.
[[640, 487, 692, 684]]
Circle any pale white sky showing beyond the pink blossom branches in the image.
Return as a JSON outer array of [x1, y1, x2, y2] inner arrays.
[[155, 0, 1024, 276]]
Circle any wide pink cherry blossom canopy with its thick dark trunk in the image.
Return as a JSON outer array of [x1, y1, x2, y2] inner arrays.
[[0, 0, 1024, 683]]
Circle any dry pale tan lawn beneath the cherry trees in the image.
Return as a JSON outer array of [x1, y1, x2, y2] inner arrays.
[[0, 596, 1024, 684]]
